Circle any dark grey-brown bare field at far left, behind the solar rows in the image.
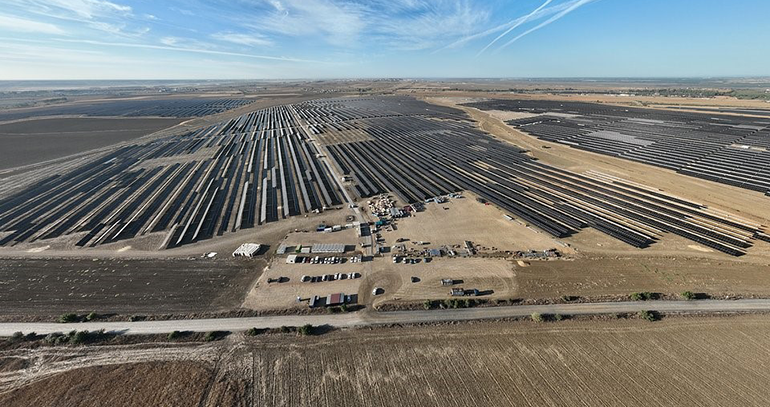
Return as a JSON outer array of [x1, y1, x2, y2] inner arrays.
[[0, 118, 181, 169]]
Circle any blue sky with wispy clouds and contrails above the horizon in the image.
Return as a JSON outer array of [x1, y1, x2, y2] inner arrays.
[[0, 0, 770, 80]]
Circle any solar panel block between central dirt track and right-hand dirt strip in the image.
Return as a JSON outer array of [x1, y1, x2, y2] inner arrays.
[[304, 98, 765, 255]]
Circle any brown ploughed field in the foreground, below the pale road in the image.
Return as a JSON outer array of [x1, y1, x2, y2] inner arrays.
[[0, 315, 770, 406]]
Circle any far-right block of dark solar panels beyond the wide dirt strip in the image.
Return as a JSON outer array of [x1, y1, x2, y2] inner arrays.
[[468, 100, 770, 195]]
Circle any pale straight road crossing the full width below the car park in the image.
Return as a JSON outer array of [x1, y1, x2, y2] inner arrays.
[[0, 299, 770, 336]]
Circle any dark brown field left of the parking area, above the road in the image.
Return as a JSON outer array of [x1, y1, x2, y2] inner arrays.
[[0, 259, 265, 318]]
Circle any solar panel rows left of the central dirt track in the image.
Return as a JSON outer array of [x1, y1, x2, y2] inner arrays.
[[0, 106, 341, 248]]
